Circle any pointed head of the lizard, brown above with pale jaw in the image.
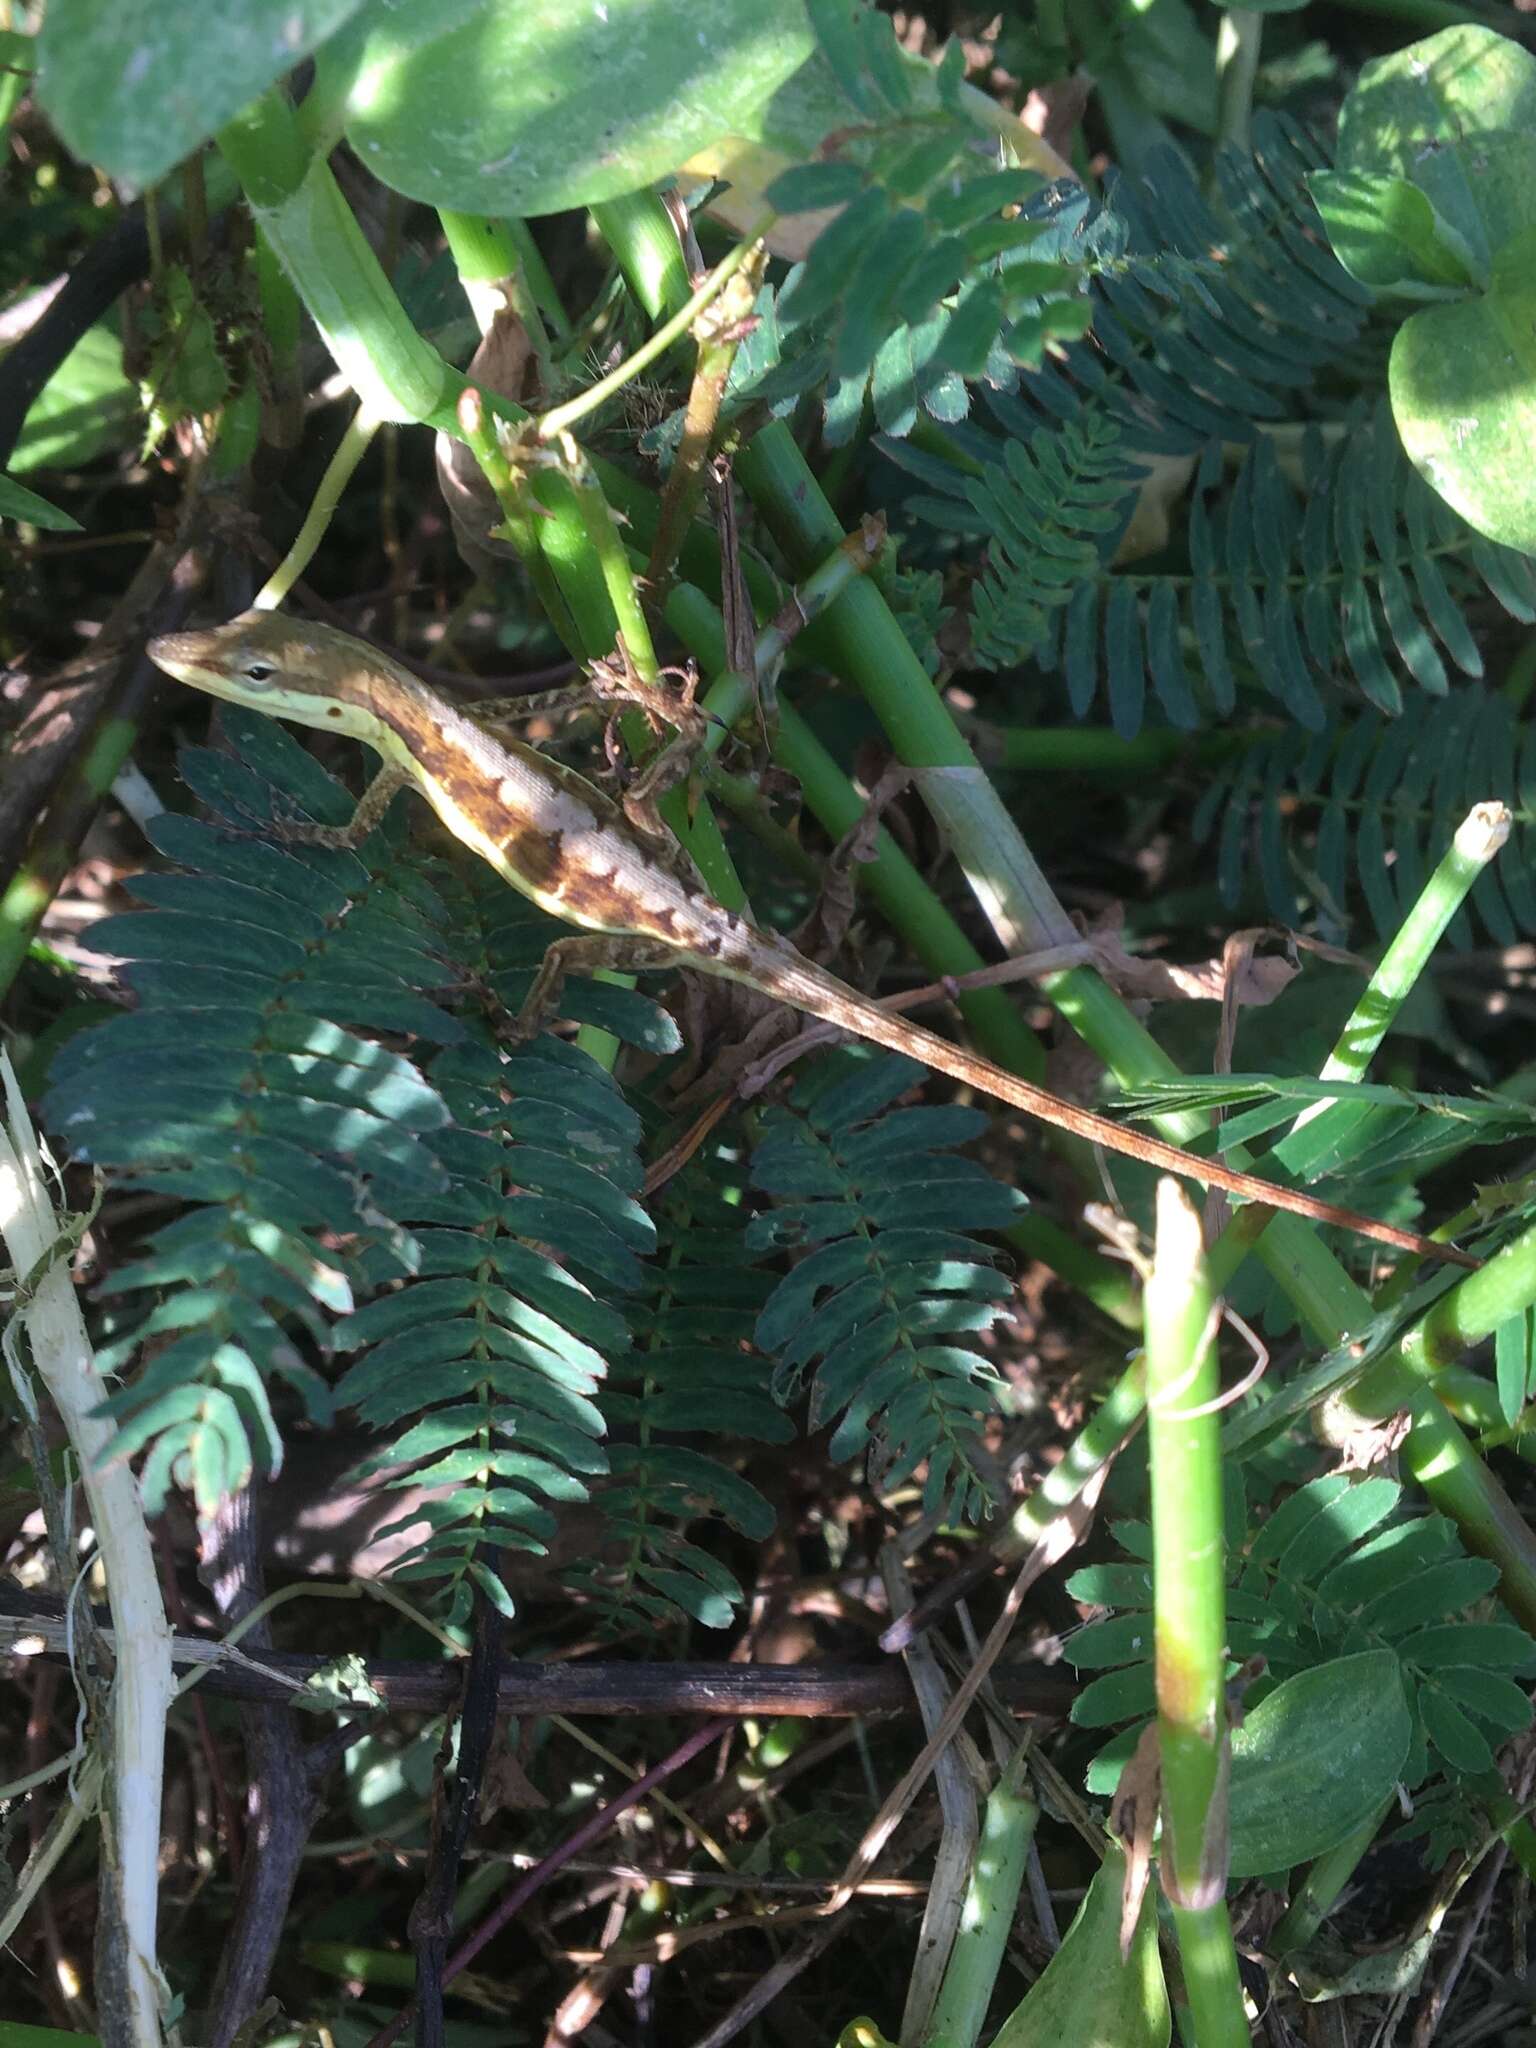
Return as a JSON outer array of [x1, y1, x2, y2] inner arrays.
[[147, 612, 391, 739]]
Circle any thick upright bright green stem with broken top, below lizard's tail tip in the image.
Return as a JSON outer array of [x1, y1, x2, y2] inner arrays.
[[1145, 1178, 1249, 2048]]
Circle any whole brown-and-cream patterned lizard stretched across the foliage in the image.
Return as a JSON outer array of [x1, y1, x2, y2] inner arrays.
[[147, 610, 1479, 1268]]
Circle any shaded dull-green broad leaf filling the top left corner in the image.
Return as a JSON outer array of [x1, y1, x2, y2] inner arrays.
[[37, 0, 362, 184]]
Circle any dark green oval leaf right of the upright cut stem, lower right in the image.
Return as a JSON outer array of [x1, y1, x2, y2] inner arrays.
[[1229, 1651, 1411, 1878]]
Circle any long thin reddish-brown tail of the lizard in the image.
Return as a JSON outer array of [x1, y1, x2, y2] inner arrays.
[[772, 948, 1481, 1272]]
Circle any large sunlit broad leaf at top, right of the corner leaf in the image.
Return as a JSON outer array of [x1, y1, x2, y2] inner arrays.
[[346, 0, 815, 215]]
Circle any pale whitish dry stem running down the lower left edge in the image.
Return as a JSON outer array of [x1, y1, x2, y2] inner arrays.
[[0, 1051, 174, 2048]]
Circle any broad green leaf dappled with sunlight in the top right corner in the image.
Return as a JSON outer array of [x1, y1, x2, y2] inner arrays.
[[1335, 25, 1536, 276]]
